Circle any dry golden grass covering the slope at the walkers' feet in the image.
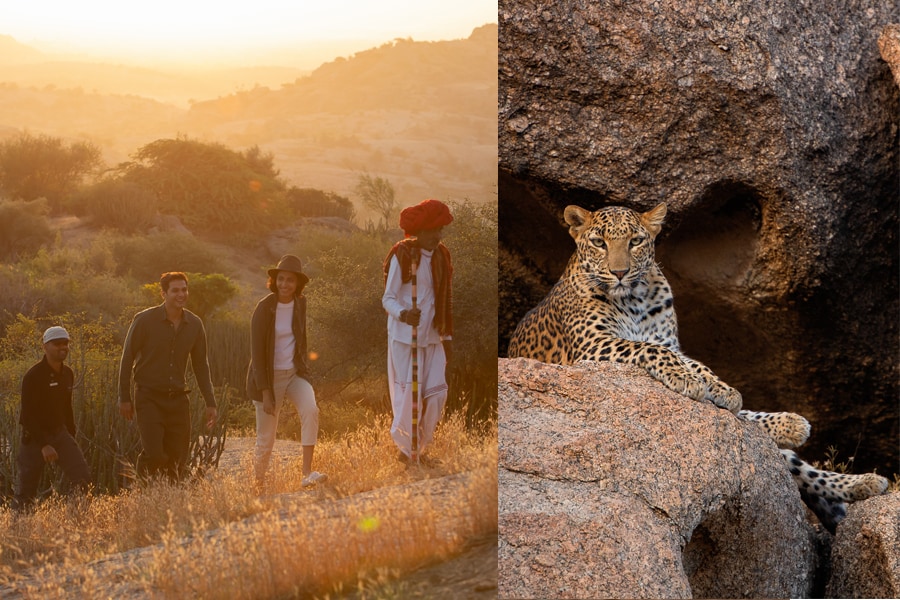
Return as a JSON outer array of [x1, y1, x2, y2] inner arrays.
[[0, 416, 497, 598]]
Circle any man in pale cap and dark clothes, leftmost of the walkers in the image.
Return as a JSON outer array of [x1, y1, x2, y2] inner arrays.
[[15, 326, 91, 509]]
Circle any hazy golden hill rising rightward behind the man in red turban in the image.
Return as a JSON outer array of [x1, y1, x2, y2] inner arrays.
[[179, 25, 497, 205]]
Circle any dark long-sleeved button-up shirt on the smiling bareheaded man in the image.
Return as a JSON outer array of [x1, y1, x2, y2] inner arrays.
[[119, 304, 216, 407]]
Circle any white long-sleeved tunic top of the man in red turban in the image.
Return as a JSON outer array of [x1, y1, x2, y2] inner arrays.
[[381, 250, 450, 346]]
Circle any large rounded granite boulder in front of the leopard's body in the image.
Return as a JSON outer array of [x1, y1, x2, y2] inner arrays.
[[499, 359, 816, 598]]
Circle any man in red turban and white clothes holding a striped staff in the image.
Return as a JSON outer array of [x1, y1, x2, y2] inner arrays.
[[381, 200, 453, 460]]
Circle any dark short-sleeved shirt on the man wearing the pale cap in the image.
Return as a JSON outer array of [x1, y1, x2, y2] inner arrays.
[[19, 356, 75, 446]]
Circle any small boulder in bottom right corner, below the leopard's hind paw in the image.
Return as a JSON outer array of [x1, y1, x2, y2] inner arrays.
[[825, 492, 900, 598]]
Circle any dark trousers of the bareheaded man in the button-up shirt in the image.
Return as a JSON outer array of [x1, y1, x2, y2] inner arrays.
[[134, 389, 191, 481]]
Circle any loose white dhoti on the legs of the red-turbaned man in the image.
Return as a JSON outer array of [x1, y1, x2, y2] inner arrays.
[[388, 340, 447, 456]]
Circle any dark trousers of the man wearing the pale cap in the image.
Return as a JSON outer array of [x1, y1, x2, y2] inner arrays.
[[15, 427, 91, 509]]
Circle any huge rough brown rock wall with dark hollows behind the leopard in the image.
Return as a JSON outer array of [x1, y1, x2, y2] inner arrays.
[[498, 0, 900, 473]]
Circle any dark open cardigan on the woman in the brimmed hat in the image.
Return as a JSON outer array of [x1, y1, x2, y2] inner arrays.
[[247, 294, 309, 402]]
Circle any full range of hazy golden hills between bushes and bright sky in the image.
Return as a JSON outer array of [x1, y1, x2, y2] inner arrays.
[[0, 24, 497, 216]]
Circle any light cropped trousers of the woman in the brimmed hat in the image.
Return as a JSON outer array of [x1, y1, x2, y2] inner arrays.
[[253, 369, 319, 480]]
